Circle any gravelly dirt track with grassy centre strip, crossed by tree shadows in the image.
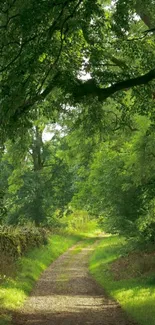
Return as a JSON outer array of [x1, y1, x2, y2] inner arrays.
[[13, 240, 135, 325]]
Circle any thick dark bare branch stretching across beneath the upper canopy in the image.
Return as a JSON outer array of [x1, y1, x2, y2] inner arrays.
[[8, 69, 155, 123]]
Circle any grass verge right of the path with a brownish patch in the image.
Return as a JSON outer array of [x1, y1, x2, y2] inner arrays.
[[90, 236, 155, 325]]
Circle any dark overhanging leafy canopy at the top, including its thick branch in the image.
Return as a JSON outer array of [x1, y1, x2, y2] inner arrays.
[[0, 0, 155, 136]]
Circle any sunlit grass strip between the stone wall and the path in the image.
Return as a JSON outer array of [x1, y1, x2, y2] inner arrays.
[[0, 235, 81, 325]]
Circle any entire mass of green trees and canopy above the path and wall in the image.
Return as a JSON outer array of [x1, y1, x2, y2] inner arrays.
[[0, 0, 155, 242]]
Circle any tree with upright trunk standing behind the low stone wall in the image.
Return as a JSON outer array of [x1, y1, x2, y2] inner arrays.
[[0, 118, 73, 225]]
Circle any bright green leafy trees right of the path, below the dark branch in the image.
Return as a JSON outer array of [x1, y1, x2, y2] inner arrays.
[[66, 115, 155, 241]]
